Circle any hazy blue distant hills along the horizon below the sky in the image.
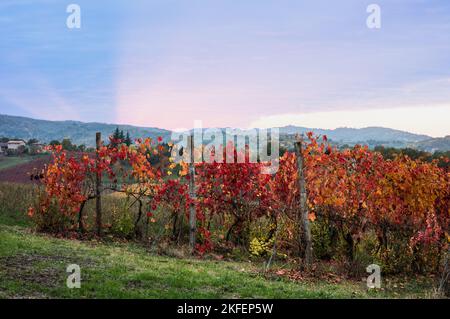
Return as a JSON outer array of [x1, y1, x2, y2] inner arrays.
[[0, 114, 442, 150]]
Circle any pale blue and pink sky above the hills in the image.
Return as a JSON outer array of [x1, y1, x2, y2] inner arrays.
[[0, 0, 450, 137]]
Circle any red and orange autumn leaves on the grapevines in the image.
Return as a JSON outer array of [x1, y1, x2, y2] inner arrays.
[[29, 133, 450, 276]]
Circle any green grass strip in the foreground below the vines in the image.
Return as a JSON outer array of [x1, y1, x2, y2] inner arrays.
[[0, 225, 438, 298]]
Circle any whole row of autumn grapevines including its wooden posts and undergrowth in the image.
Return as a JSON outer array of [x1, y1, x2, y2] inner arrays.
[[20, 134, 450, 296]]
